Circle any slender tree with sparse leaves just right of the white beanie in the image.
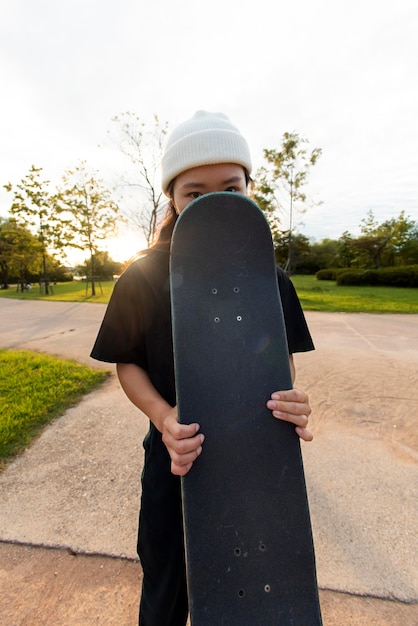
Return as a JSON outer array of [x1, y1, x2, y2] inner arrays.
[[254, 132, 322, 273]]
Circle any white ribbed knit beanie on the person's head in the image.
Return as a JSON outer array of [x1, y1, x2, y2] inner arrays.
[[161, 111, 252, 195]]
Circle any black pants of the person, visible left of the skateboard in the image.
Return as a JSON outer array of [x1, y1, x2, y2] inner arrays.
[[138, 424, 188, 626]]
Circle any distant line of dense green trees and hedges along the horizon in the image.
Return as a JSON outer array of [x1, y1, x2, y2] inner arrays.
[[0, 205, 418, 289]]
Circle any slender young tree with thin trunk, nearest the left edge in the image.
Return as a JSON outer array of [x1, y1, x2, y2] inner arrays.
[[4, 165, 62, 295]]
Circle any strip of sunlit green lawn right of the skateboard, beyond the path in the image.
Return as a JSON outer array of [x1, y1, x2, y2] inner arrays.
[[292, 276, 418, 313]]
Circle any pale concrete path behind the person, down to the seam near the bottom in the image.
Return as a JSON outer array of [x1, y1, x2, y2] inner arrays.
[[0, 299, 418, 624]]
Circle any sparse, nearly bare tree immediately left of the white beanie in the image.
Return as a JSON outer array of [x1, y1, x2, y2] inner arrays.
[[112, 112, 168, 245]]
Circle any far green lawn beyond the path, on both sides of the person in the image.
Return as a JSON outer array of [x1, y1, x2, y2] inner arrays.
[[0, 276, 418, 313]]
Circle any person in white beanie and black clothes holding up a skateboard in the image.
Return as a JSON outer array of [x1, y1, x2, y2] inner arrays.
[[91, 111, 313, 626]]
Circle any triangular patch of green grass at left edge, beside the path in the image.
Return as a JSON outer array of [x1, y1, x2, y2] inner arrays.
[[0, 350, 108, 470]]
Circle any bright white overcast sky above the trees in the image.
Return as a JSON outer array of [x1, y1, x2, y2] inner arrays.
[[0, 0, 418, 260]]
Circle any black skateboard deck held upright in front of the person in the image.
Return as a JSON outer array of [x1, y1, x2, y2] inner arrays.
[[170, 192, 322, 626]]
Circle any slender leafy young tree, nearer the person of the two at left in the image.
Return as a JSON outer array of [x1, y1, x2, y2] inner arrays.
[[53, 162, 122, 296]]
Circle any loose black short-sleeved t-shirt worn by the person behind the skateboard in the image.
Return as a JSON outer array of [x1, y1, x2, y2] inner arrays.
[[91, 250, 314, 406]]
